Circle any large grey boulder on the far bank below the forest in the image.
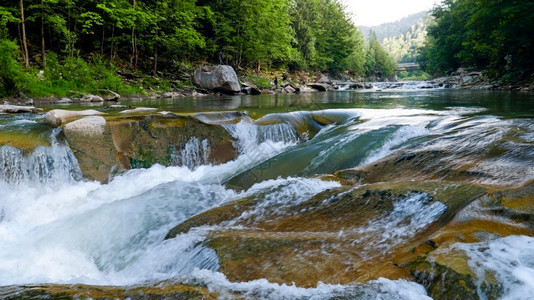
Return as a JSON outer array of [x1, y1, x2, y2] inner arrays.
[[193, 66, 241, 94]]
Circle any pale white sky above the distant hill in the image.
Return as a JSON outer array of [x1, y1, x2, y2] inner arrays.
[[350, 0, 441, 26]]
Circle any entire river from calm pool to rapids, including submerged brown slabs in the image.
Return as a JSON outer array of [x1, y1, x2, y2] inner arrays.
[[0, 88, 534, 299]]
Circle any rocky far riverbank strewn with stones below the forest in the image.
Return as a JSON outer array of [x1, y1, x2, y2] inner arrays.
[[0, 65, 534, 113]]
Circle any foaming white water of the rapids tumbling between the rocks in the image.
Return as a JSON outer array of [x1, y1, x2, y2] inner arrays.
[[0, 108, 532, 299]]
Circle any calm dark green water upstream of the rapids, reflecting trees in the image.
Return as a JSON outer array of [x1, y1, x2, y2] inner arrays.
[[38, 89, 534, 117]]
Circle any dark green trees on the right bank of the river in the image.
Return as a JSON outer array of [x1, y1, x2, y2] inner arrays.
[[418, 0, 534, 81]]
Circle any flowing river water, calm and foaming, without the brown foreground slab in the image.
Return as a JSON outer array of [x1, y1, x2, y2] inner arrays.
[[0, 86, 534, 299]]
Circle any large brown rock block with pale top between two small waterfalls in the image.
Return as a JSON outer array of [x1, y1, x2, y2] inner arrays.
[[64, 114, 238, 182]]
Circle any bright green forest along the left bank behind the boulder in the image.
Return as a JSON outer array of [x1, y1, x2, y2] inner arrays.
[[0, 0, 395, 96]]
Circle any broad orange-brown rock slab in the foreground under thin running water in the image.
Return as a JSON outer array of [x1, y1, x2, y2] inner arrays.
[[167, 182, 490, 287]]
